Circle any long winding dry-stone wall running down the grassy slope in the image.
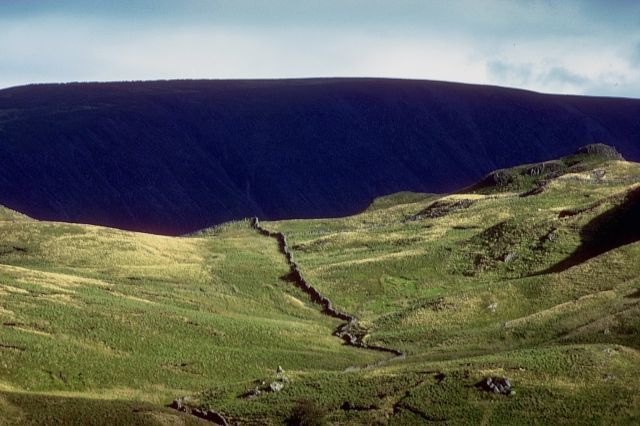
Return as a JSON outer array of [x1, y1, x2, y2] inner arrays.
[[251, 217, 405, 359]]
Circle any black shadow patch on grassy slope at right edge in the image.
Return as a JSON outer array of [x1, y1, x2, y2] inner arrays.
[[533, 188, 640, 275]]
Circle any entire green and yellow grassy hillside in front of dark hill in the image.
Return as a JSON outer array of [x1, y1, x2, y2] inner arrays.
[[0, 146, 640, 424]]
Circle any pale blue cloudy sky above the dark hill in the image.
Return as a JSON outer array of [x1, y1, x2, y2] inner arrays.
[[0, 0, 640, 98]]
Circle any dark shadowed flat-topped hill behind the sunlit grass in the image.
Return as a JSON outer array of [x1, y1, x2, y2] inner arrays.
[[0, 79, 640, 234]]
